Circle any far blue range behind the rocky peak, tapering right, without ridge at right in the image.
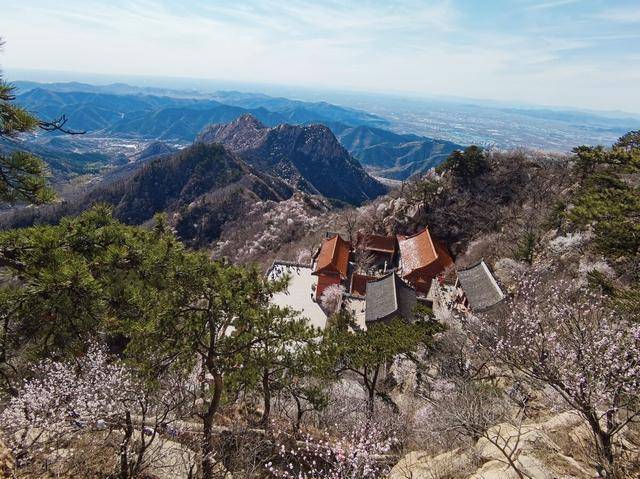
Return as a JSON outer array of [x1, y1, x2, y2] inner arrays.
[[16, 82, 386, 138]]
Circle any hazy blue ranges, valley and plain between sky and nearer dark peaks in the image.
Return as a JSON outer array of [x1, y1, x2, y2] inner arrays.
[[13, 81, 640, 201]]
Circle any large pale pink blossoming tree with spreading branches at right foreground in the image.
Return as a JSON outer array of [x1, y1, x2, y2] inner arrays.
[[493, 278, 640, 474]]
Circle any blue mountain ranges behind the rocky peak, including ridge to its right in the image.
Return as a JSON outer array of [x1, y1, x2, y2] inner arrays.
[[11, 82, 460, 180]]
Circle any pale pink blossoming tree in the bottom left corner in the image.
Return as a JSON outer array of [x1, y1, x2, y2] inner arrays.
[[1, 345, 135, 472]]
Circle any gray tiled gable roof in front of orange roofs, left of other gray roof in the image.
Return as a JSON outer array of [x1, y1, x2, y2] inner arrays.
[[365, 273, 417, 321]]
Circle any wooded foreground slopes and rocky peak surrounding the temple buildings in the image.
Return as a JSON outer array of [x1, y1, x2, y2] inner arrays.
[[0, 61, 640, 479]]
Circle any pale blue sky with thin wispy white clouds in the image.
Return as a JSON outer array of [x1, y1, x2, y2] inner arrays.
[[0, 0, 640, 113]]
